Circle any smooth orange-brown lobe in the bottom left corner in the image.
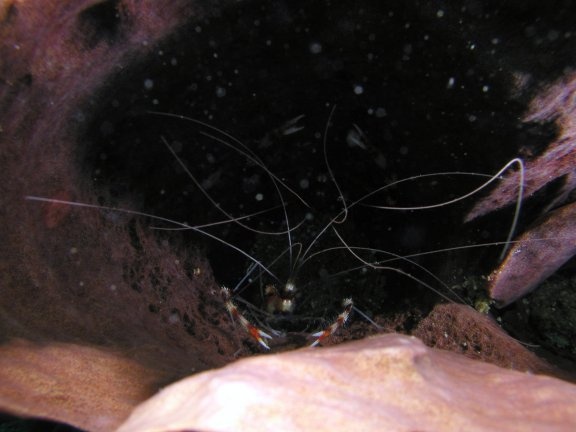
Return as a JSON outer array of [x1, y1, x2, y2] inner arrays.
[[0, 340, 166, 431]]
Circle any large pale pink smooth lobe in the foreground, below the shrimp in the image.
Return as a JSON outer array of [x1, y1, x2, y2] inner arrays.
[[119, 334, 576, 432]]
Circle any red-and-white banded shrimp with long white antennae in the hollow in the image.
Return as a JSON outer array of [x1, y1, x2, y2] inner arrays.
[[28, 102, 521, 349]]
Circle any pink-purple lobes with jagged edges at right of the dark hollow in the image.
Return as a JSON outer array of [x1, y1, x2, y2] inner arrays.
[[466, 73, 576, 306]]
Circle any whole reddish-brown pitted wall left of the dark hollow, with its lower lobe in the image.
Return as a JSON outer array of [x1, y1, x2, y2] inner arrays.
[[0, 0, 245, 430]]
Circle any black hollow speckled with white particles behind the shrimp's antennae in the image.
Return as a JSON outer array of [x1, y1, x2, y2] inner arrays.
[[72, 1, 554, 344]]
